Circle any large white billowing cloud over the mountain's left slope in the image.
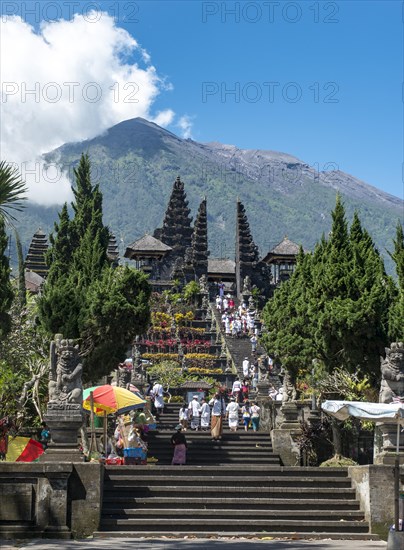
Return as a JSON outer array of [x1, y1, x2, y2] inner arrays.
[[0, 13, 174, 205]]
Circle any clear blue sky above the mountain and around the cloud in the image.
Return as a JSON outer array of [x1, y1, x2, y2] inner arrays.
[[2, 0, 403, 202]]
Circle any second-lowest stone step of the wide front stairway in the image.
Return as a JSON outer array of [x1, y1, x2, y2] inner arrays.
[[101, 517, 369, 533]]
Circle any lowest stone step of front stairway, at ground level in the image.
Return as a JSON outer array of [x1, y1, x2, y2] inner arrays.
[[94, 529, 380, 544]]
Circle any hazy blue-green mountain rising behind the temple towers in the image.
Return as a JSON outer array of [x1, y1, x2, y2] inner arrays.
[[11, 118, 404, 278]]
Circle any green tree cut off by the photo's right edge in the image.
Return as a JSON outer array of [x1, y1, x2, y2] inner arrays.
[[389, 222, 404, 342]]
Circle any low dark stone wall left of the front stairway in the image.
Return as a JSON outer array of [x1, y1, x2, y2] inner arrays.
[[0, 462, 104, 539]]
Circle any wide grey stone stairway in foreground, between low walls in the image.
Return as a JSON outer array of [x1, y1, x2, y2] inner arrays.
[[95, 462, 377, 539]]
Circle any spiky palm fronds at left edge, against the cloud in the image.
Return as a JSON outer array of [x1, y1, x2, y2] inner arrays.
[[0, 160, 27, 225]]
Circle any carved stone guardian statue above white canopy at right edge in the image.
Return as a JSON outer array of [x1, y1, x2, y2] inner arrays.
[[379, 342, 404, 403]]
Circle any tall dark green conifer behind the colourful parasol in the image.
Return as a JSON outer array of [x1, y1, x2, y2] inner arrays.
[[39, 155, 150, 381]]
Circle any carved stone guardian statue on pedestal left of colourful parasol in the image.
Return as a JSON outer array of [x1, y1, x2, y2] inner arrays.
[[48, 334, 83, 405]]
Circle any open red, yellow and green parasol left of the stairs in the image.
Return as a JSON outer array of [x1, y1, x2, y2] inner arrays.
[[83, 384, 146, 414]]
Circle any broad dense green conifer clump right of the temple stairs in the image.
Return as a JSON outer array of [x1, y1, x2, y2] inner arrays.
[[264, 196, 394, 383]]
